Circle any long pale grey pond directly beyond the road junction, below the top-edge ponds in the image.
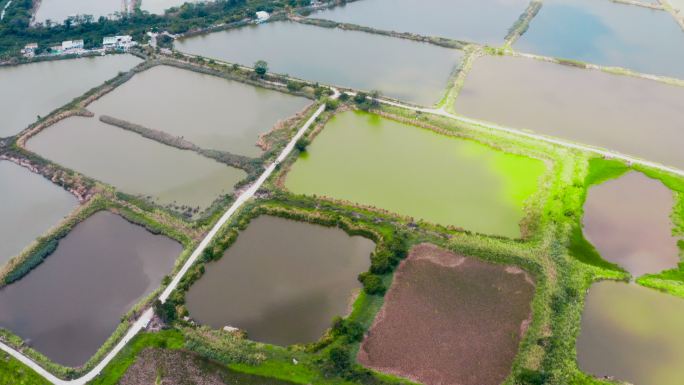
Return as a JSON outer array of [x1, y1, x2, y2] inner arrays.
[[176, 21, 463, 105]]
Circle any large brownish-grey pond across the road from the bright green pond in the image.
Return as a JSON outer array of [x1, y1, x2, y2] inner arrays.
[[455, 54, 684, 168]]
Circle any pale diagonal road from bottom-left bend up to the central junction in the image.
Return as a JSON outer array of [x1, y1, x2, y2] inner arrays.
[[0, 88, 340, 385]]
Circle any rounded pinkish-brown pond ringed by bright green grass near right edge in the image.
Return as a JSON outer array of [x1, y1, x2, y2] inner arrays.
[[583, 172, 679, 277]]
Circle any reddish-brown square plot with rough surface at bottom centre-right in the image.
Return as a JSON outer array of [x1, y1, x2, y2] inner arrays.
[[357, 244, 534, 385]]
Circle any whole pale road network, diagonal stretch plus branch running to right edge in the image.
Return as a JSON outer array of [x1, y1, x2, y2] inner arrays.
[[0, 54, 684, 385]]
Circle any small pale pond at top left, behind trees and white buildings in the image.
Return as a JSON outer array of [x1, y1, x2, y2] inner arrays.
[[35, 0, 126, 24]]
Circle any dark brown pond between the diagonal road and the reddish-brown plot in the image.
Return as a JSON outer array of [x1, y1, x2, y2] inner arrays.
[[187, 216, 375, 345]]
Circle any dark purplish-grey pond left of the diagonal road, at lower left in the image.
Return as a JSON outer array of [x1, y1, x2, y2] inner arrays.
[[0, 212, 182, 366]]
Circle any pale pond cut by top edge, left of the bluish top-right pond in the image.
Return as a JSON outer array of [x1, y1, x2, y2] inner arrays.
[[311, 0, 529, 46]]
